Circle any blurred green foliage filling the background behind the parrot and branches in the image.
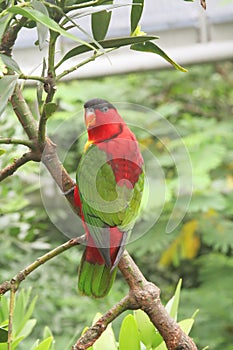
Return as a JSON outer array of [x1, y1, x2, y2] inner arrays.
[[0, 62, 233, 350]]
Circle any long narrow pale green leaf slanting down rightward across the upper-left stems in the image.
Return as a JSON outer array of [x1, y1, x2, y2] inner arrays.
[[8, 6, 93, 49]]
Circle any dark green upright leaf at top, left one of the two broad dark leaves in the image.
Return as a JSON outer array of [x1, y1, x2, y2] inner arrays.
[[91, 10, 112, 41]]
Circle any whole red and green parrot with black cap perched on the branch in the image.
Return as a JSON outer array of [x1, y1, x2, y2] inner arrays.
[[74, 98, 145, 298]]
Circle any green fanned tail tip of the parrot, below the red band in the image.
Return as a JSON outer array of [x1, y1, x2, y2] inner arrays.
[[78, 256, 116, 298]]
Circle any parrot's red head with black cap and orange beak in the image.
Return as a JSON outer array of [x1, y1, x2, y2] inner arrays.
[[84, 98, 125, 142]]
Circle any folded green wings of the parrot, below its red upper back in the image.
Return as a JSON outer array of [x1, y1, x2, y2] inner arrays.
[[77, 145, 144, 266]]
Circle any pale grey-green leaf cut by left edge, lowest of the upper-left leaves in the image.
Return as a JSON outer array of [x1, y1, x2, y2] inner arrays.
[[0, 75, 18, 116]]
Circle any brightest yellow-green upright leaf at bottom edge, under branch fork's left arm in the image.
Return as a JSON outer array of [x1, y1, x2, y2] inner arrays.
[[119, 315, 140, 350]]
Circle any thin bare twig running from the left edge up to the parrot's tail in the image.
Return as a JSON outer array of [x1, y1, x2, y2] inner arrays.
[[0, 235, 85, 295]]
